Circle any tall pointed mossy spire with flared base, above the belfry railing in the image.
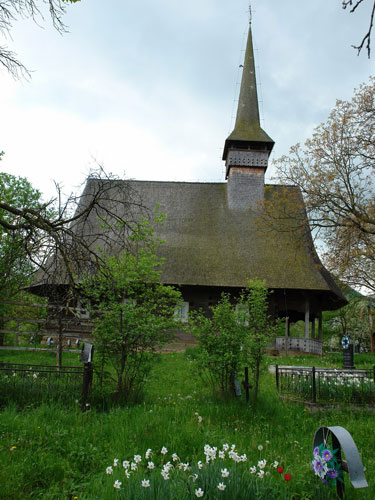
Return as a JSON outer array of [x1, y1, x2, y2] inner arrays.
[[223, 24, 274, 160]]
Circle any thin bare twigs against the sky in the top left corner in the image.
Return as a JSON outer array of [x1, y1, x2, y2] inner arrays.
[[0, 0, 80, 78]]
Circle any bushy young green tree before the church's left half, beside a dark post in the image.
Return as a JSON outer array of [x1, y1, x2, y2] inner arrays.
[[80, 223, 182, 400]]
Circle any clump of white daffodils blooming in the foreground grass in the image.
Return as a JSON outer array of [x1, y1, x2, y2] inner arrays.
[[106, 443, 292, 500]]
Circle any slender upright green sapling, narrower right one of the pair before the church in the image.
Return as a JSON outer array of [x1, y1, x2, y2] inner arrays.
[[237, 281, 277, 404]]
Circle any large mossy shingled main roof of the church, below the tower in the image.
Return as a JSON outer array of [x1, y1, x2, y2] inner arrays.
[[53, 179, 341, 304]]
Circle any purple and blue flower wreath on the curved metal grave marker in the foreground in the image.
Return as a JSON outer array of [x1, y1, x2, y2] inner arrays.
[[311, 443, 343, 486]]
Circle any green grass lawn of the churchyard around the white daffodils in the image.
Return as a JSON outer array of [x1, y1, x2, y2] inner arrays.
[[0, 351, 375, 500]]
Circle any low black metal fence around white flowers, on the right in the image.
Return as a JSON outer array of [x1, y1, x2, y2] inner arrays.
[[275, 365, 375, 404]]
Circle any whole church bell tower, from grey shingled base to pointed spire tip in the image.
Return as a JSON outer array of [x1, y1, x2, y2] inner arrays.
[[223, 23, 274, 210]]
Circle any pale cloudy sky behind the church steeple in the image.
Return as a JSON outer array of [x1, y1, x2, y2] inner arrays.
[[0, 0, 375, 197]]
